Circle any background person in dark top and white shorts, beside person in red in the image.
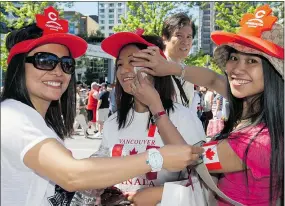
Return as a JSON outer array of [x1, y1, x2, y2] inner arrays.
[[97, 83, 110, 136]]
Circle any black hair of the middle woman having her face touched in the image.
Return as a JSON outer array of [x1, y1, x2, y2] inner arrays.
[[115, 35, 175, 129]]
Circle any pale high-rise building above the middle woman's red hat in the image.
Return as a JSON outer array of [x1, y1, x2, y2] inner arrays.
[[98, 2, 127, 37]]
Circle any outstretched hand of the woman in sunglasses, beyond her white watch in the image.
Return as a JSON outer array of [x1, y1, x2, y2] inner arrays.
[[159, 144, 204, 172]]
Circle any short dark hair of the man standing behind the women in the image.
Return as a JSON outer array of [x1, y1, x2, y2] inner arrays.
[[162, 13, 196, 40]]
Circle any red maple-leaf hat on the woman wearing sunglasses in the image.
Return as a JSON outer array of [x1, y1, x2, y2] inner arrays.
[[7, 6, 88, 63]]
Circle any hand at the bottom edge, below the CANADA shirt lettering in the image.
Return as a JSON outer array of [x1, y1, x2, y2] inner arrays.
[[128, 187, 163, 206]]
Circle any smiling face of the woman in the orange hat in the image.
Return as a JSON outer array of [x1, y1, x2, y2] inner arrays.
[[226, 52, 264, 98]]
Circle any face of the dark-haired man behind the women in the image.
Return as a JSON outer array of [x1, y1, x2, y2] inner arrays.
[[164, 25, 193, 60]]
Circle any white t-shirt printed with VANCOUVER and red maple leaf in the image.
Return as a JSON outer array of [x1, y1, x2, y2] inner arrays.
[[101, 103, 205, 193]]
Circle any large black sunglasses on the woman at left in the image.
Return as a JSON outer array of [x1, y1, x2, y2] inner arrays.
[[26, 52, 75, 74]]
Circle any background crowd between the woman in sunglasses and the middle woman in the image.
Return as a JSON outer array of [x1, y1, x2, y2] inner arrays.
[[73, 81, 117, 138]]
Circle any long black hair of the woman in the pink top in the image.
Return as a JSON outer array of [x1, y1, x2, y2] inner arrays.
[[217, 48, 284, 204]]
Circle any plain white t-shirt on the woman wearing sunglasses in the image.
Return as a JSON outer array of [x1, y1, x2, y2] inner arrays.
[[1, 99, 74, 206]]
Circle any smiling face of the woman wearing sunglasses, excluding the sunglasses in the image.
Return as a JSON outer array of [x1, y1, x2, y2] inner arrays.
[[25, 44, 71, 103]]
